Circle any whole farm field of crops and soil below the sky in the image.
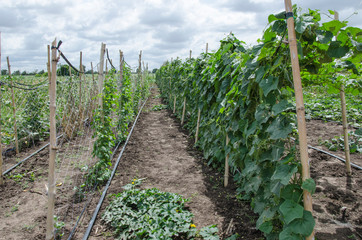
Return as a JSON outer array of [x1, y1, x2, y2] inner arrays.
[[0, 5, 362, 240]]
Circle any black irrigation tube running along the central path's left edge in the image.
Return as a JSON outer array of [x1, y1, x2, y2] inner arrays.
[[83, 98, 148, 240]]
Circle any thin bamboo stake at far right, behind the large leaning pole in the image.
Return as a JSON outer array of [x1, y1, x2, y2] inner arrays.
[[334, 11, 352, 176]]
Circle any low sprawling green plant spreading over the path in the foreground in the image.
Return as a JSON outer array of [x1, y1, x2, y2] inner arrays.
[[102, 179, 219, 239]]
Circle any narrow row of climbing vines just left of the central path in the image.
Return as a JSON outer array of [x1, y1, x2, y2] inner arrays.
[[83, 66, 151, 188]]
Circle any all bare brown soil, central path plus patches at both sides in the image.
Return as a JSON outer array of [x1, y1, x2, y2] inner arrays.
[[0, 89, 362, 240]]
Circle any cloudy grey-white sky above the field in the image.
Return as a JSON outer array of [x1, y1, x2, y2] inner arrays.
[[0, 0, 362, 71]]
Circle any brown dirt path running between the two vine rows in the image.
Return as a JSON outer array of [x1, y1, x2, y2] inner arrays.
[[83, 89, 263, 239]]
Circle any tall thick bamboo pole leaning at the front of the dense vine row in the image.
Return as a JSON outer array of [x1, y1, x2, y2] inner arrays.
[[284, 0, 314, 240]]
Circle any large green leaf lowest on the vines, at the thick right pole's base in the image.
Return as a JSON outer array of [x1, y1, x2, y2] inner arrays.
[[287, 210, 315, 237]]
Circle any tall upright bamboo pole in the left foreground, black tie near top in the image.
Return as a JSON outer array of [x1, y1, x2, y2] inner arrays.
[[46, 39, 58, 240]]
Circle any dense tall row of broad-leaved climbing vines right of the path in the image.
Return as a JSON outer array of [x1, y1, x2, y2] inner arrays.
[[156, 6, 362, 239]]
